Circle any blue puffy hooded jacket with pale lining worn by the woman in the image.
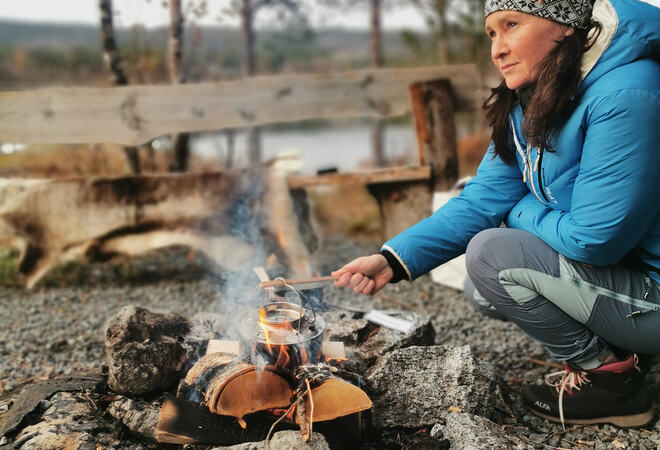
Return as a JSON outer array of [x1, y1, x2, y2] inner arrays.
[[383, 0, 660, 283]]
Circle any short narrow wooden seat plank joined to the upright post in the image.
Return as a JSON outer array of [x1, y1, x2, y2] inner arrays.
[[288, 166, 431, 189]]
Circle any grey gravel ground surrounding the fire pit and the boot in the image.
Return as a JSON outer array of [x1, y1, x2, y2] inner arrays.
[[0, 241, 660, 449]]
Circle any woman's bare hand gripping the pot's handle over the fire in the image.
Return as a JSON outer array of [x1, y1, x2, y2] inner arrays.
[[332, 254, 394, 295]]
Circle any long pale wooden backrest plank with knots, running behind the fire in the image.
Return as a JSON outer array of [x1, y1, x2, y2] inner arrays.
[[0, 65, 479, 145]]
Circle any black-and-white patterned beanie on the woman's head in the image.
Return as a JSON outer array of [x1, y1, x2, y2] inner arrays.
[[484, 0, 594, 28]]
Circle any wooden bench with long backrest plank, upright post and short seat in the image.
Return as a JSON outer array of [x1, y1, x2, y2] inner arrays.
[[0, 65, 480, 251]]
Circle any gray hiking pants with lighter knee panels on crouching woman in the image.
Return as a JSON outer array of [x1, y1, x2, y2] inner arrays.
[[466, 228, 660, 369]]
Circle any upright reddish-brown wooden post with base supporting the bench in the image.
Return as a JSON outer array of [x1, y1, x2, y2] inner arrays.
[[368, 80, 458, 239]]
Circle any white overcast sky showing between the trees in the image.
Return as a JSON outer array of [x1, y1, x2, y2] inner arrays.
[[0, 0, 424, 29]]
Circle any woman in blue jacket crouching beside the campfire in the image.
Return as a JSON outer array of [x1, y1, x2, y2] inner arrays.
[[333, 0, 660, 426]]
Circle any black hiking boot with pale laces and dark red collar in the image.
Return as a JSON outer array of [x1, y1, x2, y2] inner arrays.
[[523, 354, 653, 427]]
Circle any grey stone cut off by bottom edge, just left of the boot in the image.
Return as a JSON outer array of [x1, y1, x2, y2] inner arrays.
[[431, 412, 527, 450]]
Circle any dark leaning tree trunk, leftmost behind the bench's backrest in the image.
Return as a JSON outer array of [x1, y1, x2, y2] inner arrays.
[[99, 0, 140, 174]]
